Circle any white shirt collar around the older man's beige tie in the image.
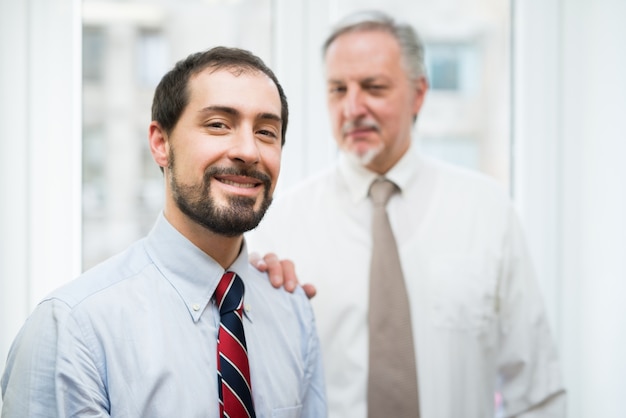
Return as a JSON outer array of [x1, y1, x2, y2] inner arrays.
[[339, 142, 419, 202]]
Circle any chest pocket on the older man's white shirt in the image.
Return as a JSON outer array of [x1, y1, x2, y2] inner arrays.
[[427, 254, 498, 331]]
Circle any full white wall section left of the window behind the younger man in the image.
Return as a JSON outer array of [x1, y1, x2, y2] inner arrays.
[[0, 0, 81, 408]]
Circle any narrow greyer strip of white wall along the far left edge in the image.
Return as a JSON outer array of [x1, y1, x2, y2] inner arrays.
[[0, 1, 30, 380]]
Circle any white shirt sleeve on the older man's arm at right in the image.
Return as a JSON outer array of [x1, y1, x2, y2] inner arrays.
[[498, 208, 565, 418]]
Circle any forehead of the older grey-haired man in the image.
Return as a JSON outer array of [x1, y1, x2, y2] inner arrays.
[[325, 30, 406, 80]]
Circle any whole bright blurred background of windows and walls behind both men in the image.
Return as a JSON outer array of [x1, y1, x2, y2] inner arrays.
[[0, 0, 626, 418]]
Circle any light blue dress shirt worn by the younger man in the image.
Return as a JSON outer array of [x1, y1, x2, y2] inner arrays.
[[2, 215, 326, 418]]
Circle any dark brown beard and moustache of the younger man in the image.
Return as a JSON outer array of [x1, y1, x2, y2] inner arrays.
[[168, 153, 272, 237]]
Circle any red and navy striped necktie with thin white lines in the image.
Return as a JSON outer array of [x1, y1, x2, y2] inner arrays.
[[215, 272, 256, 418]]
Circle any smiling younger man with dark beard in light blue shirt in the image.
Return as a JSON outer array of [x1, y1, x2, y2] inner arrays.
[[2, 47, 326, 418]]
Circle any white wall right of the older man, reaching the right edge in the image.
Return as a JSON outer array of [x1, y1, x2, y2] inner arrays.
[[515, 0, 626, 418]]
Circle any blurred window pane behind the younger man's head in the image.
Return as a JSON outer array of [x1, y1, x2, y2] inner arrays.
[[83, 0, 272, 269]]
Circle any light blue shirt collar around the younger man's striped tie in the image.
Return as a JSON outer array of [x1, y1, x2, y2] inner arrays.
[[146, 213, 248, 322]]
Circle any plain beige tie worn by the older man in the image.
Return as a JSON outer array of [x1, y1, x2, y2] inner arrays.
[[367, 179, 419, 418]]
